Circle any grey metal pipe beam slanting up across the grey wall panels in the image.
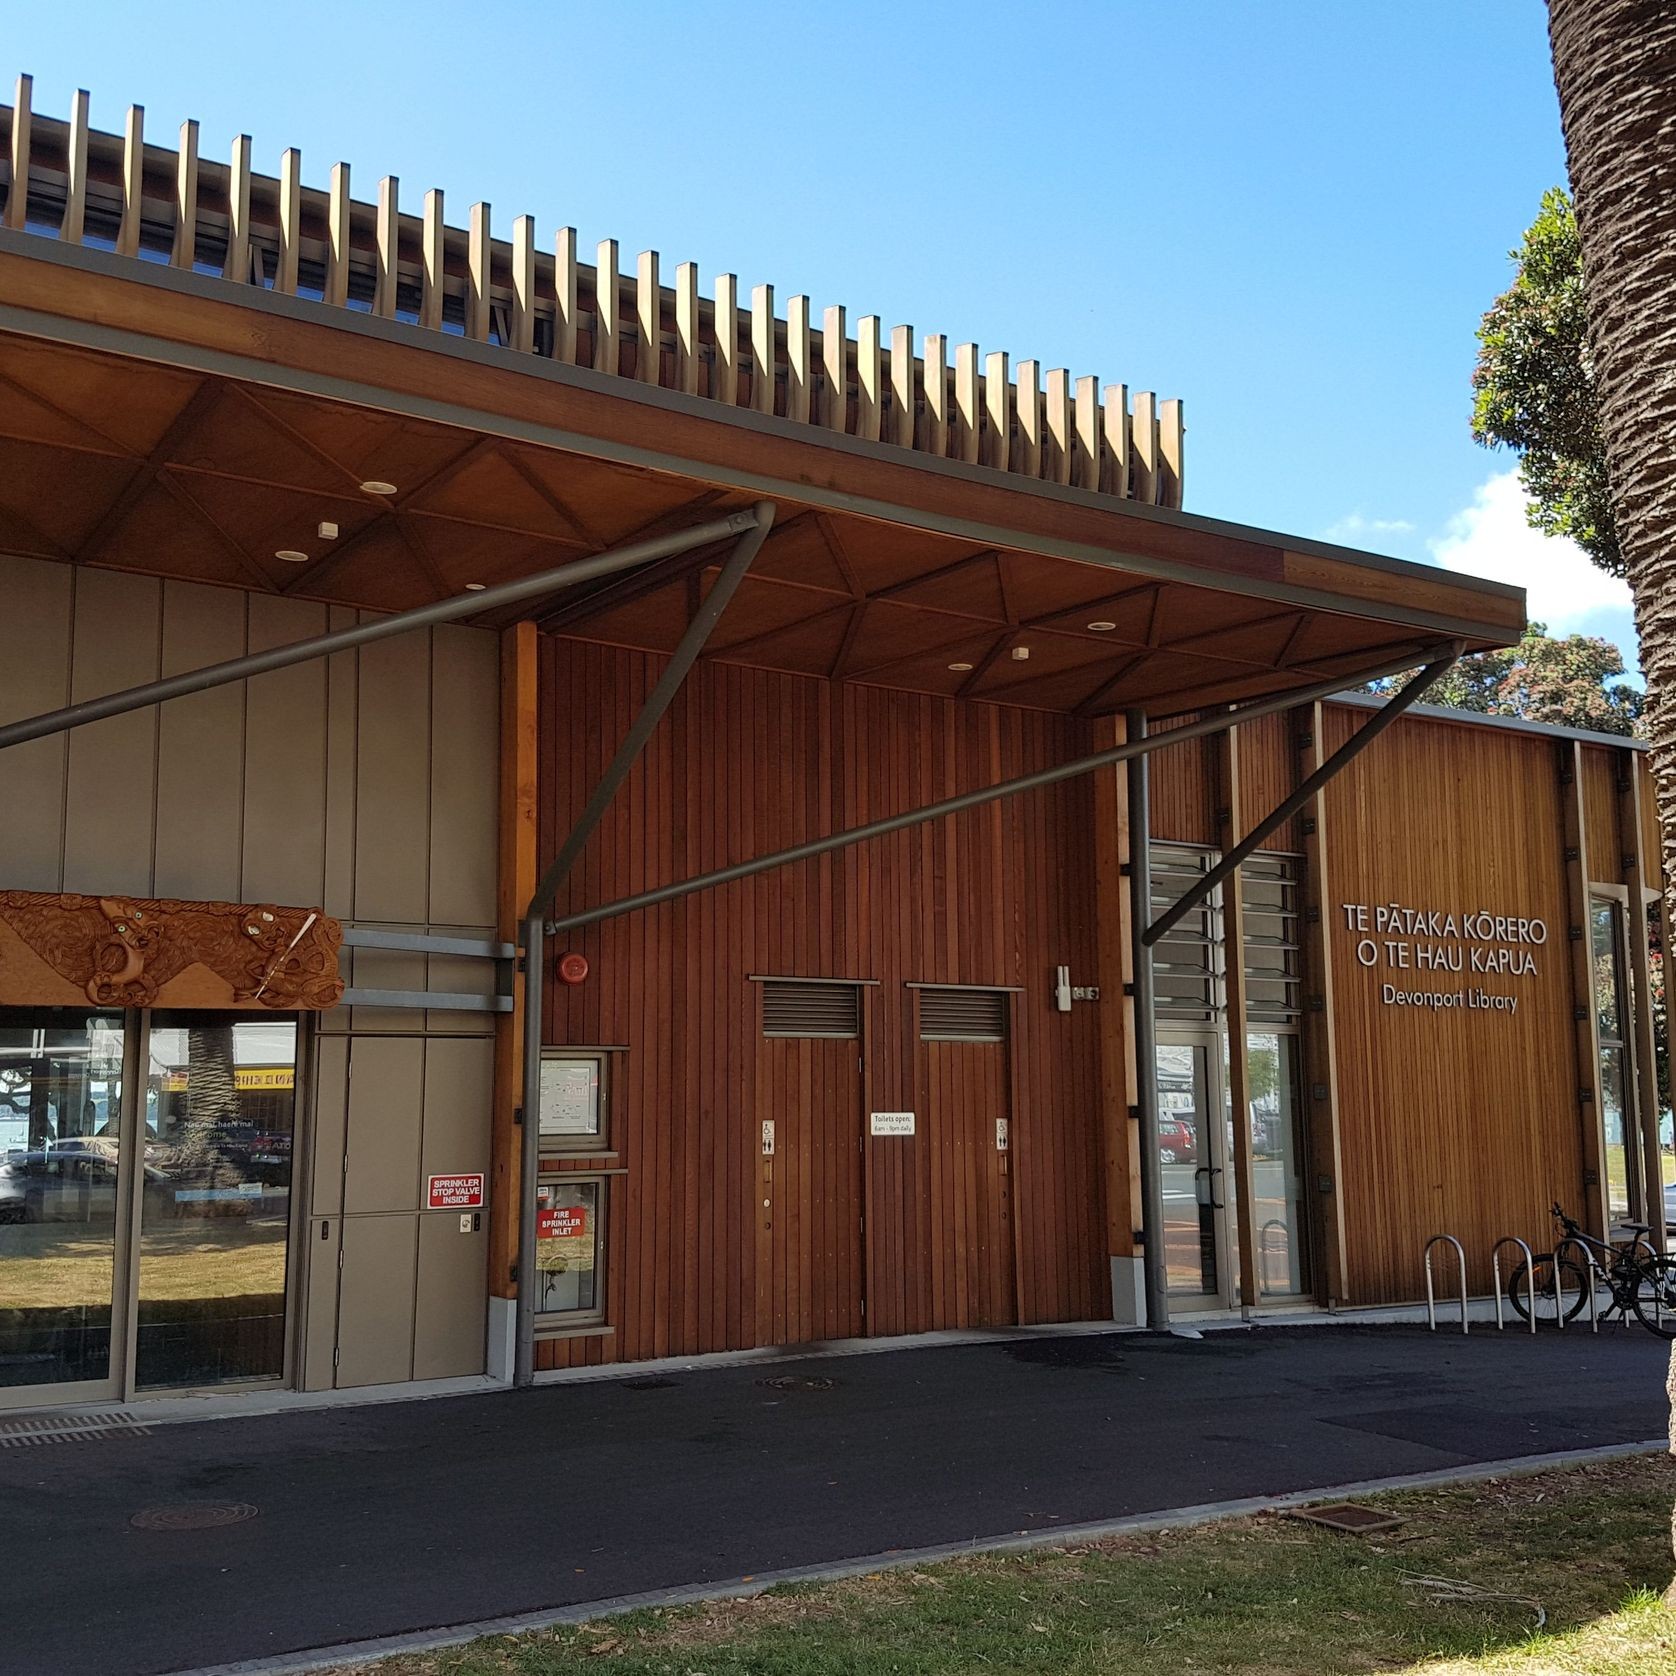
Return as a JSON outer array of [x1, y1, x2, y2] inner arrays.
[[0, 513, 758, 751]]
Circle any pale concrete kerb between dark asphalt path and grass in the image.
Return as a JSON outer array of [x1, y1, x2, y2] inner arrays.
[[169, 1438, 1671, 1676]]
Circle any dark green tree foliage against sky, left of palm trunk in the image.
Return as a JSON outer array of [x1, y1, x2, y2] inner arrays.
[[1472, 186, 1624, 577]]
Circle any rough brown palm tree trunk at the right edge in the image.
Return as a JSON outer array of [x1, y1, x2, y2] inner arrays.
[[1549, 0, 1676, 1606]]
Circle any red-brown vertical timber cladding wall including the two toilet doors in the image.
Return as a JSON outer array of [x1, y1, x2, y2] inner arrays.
[[538, 639, 1121, 1368]]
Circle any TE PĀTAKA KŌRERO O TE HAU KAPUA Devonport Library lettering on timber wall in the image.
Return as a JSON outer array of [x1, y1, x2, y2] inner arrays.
[[1339, 902, 1549, 1012]]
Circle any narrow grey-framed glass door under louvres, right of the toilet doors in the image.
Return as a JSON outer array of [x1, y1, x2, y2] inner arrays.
[[1156, 1031, 1239, 1311]]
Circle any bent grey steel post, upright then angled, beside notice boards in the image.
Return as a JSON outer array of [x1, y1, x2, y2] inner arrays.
[[513, 501, 774, 1384]]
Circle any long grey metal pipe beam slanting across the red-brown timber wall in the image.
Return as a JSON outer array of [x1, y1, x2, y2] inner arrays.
[[546, 645, 1455, 935]]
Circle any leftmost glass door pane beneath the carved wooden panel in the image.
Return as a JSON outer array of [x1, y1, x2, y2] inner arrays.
[[0, 1007, 122, 1386]]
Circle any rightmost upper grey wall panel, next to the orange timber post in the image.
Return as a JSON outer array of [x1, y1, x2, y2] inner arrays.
[[431, 625, 499, 925]]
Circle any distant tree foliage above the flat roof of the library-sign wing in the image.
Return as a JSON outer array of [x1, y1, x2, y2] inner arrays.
[[1371, 623, 1646, 737]]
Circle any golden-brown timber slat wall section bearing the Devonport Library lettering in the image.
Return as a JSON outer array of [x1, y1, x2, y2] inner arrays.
[[1306, 707, 1592, 1302]]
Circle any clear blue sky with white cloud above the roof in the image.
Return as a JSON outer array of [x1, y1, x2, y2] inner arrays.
[[0, 0, 1632, 667]]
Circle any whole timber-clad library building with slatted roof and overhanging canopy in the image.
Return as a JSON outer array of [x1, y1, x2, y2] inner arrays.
[[0, 79, 1666, 1404]]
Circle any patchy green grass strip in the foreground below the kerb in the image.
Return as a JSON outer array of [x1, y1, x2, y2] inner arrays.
[[343, 1456, 1676, 1676]]
